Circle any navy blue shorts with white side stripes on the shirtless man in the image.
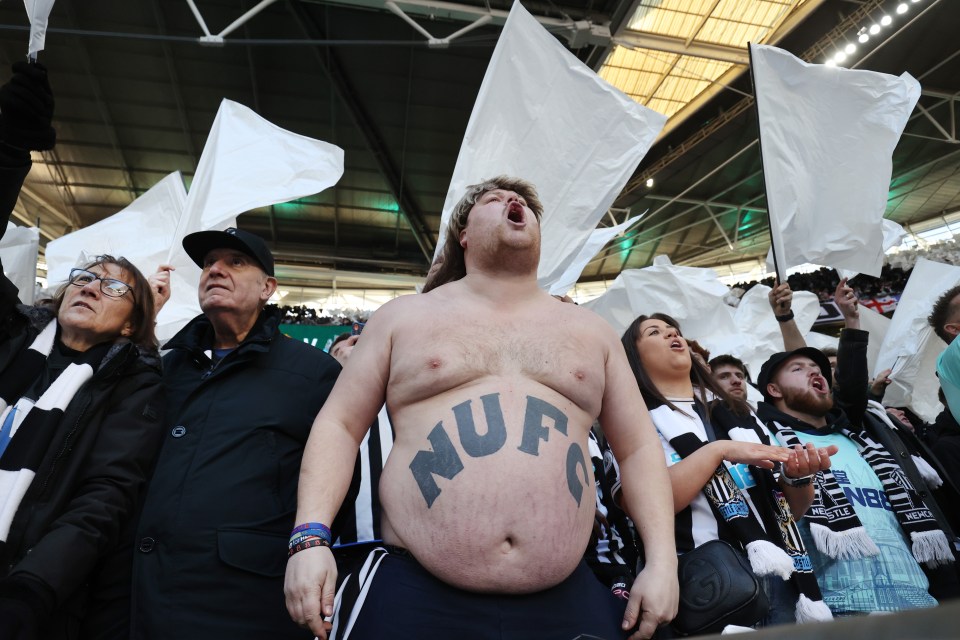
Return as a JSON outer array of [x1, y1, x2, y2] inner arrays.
[[331, 549, 626, 640]]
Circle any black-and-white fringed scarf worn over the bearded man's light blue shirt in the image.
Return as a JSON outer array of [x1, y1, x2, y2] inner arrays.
[[767, 420, 953, 567]]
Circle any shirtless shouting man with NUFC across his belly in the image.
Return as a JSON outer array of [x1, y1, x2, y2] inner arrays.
[[285, 177, 678, 640]]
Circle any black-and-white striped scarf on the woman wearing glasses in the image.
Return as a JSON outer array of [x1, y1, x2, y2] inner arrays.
[[0, 320, 104, 543]]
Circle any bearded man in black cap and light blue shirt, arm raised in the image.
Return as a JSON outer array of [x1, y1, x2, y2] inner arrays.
[[757, 280, 954, 615]]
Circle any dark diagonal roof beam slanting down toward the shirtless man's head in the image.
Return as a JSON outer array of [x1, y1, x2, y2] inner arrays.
[[287, 2, 436, 262]]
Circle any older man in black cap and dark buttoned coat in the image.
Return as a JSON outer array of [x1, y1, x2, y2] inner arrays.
[[132, 228, 340, 640]]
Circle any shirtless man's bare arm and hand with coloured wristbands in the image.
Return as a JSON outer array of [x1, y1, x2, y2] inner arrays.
[[284, 298, 400, 638]]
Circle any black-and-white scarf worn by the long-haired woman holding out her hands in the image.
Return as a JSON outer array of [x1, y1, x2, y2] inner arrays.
[[650, 402, 833, 623]]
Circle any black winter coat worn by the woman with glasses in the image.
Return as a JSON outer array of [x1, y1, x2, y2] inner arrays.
[[0, 151, 163, 640]]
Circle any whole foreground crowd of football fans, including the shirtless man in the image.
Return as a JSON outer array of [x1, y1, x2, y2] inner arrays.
[[0, 62, 960, 640]]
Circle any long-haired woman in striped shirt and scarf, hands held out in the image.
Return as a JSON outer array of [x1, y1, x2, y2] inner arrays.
[[622, 313, 830, 624]]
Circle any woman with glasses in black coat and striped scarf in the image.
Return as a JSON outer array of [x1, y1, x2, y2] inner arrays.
[[0, 252, 162, 639]]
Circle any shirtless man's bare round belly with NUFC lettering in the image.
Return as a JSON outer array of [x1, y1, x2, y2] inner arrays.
[[380, 383, 595, 593]]
